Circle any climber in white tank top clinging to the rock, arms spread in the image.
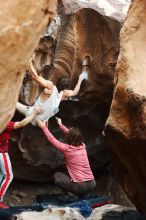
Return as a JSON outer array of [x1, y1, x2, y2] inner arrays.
[[16, 58, 87, 125]]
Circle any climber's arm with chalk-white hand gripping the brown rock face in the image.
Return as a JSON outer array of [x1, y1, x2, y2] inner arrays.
[[62, 72, 88, 100]]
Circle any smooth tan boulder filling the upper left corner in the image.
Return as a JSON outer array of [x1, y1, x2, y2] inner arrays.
[[0, 0, 57, 131]]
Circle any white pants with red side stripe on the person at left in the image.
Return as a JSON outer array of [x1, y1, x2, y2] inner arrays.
[[0, 153, 13, 201]]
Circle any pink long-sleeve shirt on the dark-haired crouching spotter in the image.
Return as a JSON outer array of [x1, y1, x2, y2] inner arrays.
[[43, 124, 94, 182]]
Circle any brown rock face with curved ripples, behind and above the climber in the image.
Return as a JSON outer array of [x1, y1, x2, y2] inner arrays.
[[49, 9, 120, 107]]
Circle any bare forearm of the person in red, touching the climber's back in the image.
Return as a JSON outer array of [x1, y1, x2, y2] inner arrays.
[[14, 109, 41, 129]]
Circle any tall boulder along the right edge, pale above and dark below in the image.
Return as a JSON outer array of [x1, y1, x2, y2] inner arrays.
[[106, 0, 146, 214]]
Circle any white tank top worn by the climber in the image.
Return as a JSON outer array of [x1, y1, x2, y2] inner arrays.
[[28, 86, 63, 125]]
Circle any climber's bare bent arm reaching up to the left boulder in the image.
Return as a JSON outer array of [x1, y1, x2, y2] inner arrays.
[[30, 60, 53, 89]]
